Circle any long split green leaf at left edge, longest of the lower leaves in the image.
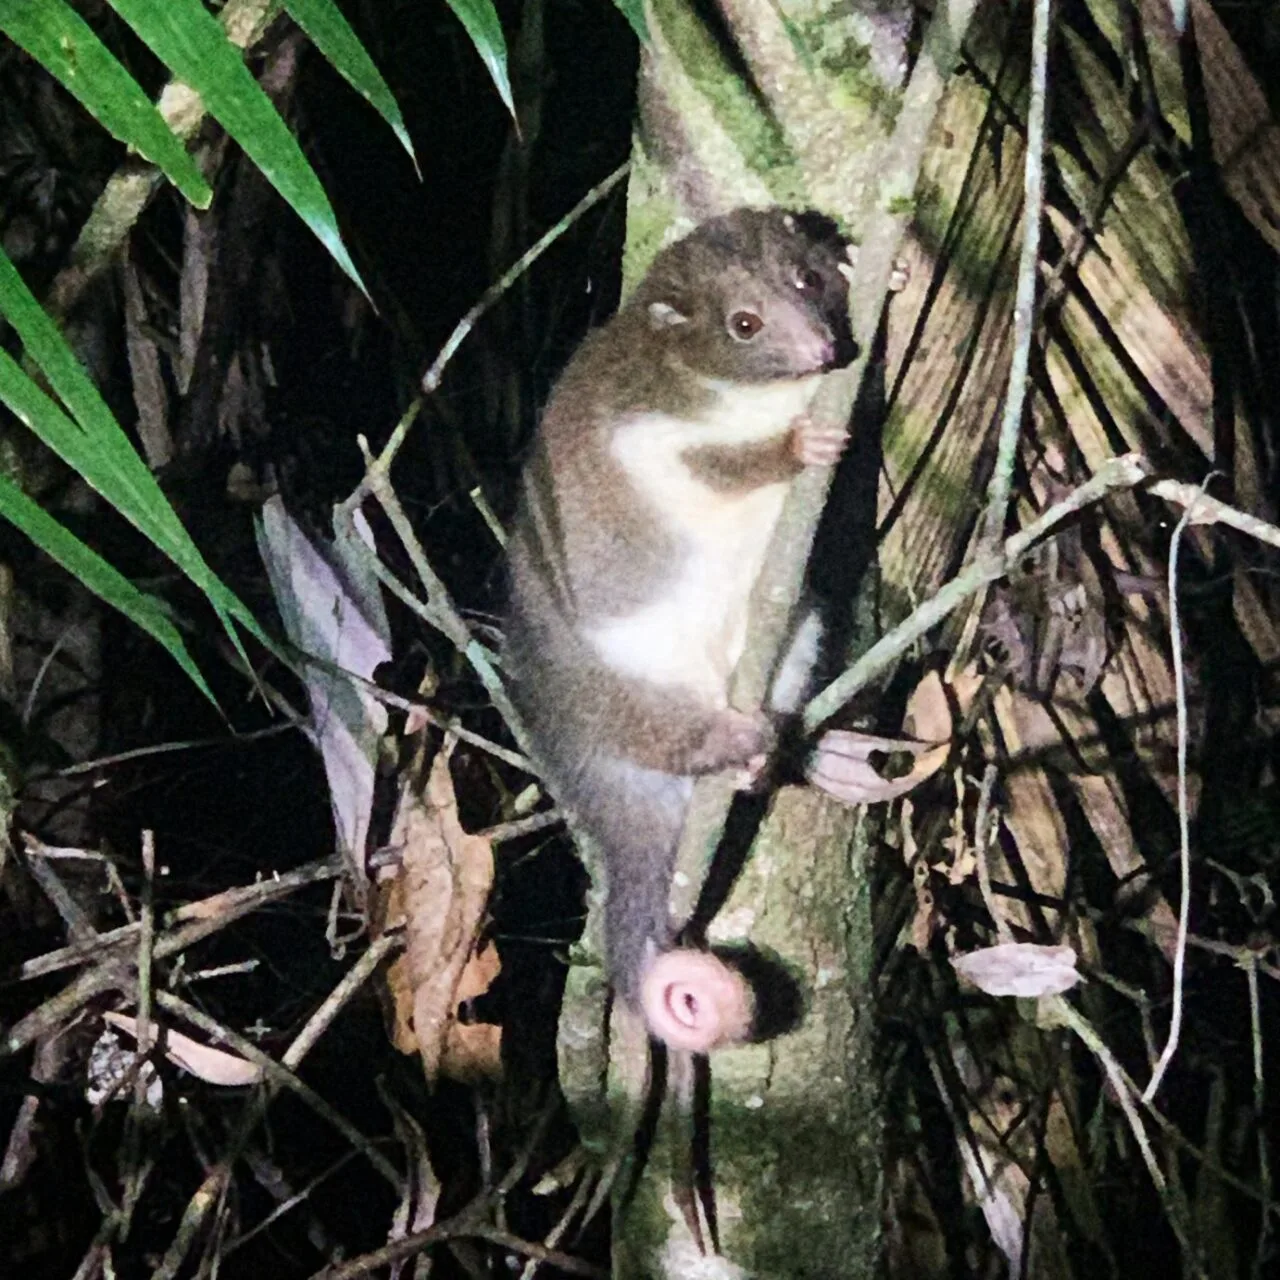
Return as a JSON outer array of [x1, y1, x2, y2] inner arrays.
[[0, 241, 275, 680]]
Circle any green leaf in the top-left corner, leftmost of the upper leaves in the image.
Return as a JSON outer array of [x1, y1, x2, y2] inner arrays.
[[0, 0, 212, 209]]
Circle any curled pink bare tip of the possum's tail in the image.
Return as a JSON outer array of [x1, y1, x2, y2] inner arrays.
[[640, 947, 755, 1053]]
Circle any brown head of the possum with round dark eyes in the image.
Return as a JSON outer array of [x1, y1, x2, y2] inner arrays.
[[631, 209, 858, 385]]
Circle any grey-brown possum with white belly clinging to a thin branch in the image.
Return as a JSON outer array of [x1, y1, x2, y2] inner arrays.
[[504, 209, 856, 1052]]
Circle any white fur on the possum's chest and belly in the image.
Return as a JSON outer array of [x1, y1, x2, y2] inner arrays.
[[586, 378, 817, 707]]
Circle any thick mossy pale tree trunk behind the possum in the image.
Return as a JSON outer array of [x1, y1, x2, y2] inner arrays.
[[561, 0, 911, 1277]]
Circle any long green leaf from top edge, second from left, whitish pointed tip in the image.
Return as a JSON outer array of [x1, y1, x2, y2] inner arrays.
[[110, 0, 367, 292]]
